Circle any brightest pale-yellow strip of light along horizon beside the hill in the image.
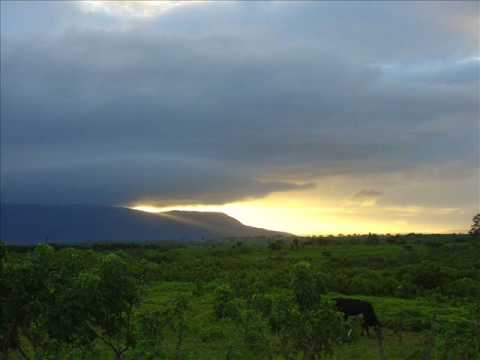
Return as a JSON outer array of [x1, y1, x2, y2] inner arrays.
[[131, 198, 447, 236]]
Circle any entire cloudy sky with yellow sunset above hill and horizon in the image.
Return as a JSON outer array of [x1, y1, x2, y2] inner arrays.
[[0, 1, 480, 235]]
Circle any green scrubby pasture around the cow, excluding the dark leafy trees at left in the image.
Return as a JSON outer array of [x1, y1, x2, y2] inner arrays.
[[3, 236, 480, 360]]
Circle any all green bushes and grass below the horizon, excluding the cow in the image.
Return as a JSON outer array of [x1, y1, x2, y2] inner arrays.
[[0, 234, 480, 360]]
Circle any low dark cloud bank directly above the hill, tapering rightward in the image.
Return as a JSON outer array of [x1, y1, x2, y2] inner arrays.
[[3, 155, 313, 205]]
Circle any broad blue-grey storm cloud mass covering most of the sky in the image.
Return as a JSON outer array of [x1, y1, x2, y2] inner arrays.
[[1, 3, 479, 204]]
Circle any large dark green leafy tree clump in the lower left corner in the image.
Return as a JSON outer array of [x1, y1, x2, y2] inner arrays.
[[0, 245, 139, 359]]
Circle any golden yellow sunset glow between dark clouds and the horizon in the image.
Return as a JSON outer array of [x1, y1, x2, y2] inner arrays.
[[131, 188, 461, 235]]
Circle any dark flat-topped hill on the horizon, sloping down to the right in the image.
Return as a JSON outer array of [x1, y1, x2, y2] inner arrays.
[[0, 204, 288, 245]]
